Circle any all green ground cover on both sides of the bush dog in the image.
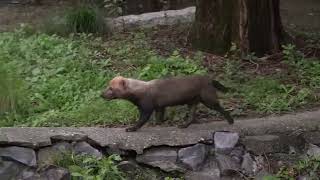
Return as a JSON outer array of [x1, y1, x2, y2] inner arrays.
[[0, 26, 320, 126]]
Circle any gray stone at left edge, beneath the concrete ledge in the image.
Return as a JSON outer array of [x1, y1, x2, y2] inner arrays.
[[0, 146, 37, 167]]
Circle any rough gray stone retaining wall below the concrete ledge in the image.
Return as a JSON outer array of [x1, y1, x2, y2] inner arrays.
[[0, 128, 320, 180]]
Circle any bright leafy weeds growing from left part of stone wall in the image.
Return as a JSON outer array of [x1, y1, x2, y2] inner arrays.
[[55, 154, 125, 180]]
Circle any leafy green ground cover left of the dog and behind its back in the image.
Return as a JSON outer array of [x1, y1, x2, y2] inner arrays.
[[0, 30, 203, 126]]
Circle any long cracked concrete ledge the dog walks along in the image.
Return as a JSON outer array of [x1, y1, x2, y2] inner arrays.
[[0, 110, 320, 154]]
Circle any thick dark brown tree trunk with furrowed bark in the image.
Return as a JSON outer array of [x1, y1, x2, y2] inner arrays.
[[190, 0, 283, 56]]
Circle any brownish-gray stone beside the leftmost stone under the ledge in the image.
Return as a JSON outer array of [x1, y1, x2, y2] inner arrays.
[[37, 142, 72, 165]]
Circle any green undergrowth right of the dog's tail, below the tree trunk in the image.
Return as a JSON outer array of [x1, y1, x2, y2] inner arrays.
[[222, 42, 320, 114]]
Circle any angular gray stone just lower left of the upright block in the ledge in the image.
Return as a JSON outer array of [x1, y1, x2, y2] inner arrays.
[[178, 144, 207, 170]]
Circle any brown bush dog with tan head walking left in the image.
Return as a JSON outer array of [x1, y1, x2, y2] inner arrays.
[[101, 75, 233, 132]]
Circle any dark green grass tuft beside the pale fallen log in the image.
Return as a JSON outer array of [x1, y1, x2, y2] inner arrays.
[[66, 5, 106, 33]]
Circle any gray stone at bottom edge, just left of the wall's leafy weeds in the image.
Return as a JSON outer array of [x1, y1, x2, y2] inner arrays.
[[40, 166, 71, 180]]
